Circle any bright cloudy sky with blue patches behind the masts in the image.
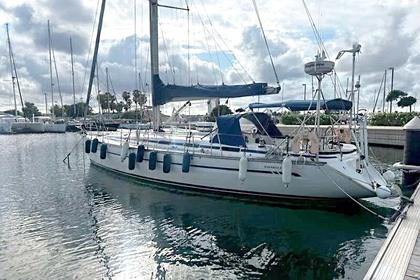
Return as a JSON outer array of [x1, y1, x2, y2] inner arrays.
[[0, 0, 420, 114]]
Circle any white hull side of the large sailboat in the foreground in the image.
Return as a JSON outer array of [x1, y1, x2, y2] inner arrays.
[[89, 141, 375, 199]]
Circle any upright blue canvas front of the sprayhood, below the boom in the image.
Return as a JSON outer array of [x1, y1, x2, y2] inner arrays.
[[211, 115, 246, 147]]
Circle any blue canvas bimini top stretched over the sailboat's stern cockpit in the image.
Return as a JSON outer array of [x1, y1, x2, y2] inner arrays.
[[249, 98, 352, 111]]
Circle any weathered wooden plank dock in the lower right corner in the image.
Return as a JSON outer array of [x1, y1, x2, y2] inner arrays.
[[364, 184, 420, 280]]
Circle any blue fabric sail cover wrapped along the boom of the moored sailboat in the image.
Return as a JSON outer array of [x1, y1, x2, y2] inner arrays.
[[152, 75, 278, 106]]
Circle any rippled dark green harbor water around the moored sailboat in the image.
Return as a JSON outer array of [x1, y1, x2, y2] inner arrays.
[[0, 134, 402, 279]]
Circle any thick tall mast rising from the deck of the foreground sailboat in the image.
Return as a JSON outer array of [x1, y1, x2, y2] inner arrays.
[[149, 0, 160, 131]]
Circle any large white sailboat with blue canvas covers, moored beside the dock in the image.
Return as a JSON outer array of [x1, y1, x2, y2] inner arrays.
[[85, 0, 398, 200]]
